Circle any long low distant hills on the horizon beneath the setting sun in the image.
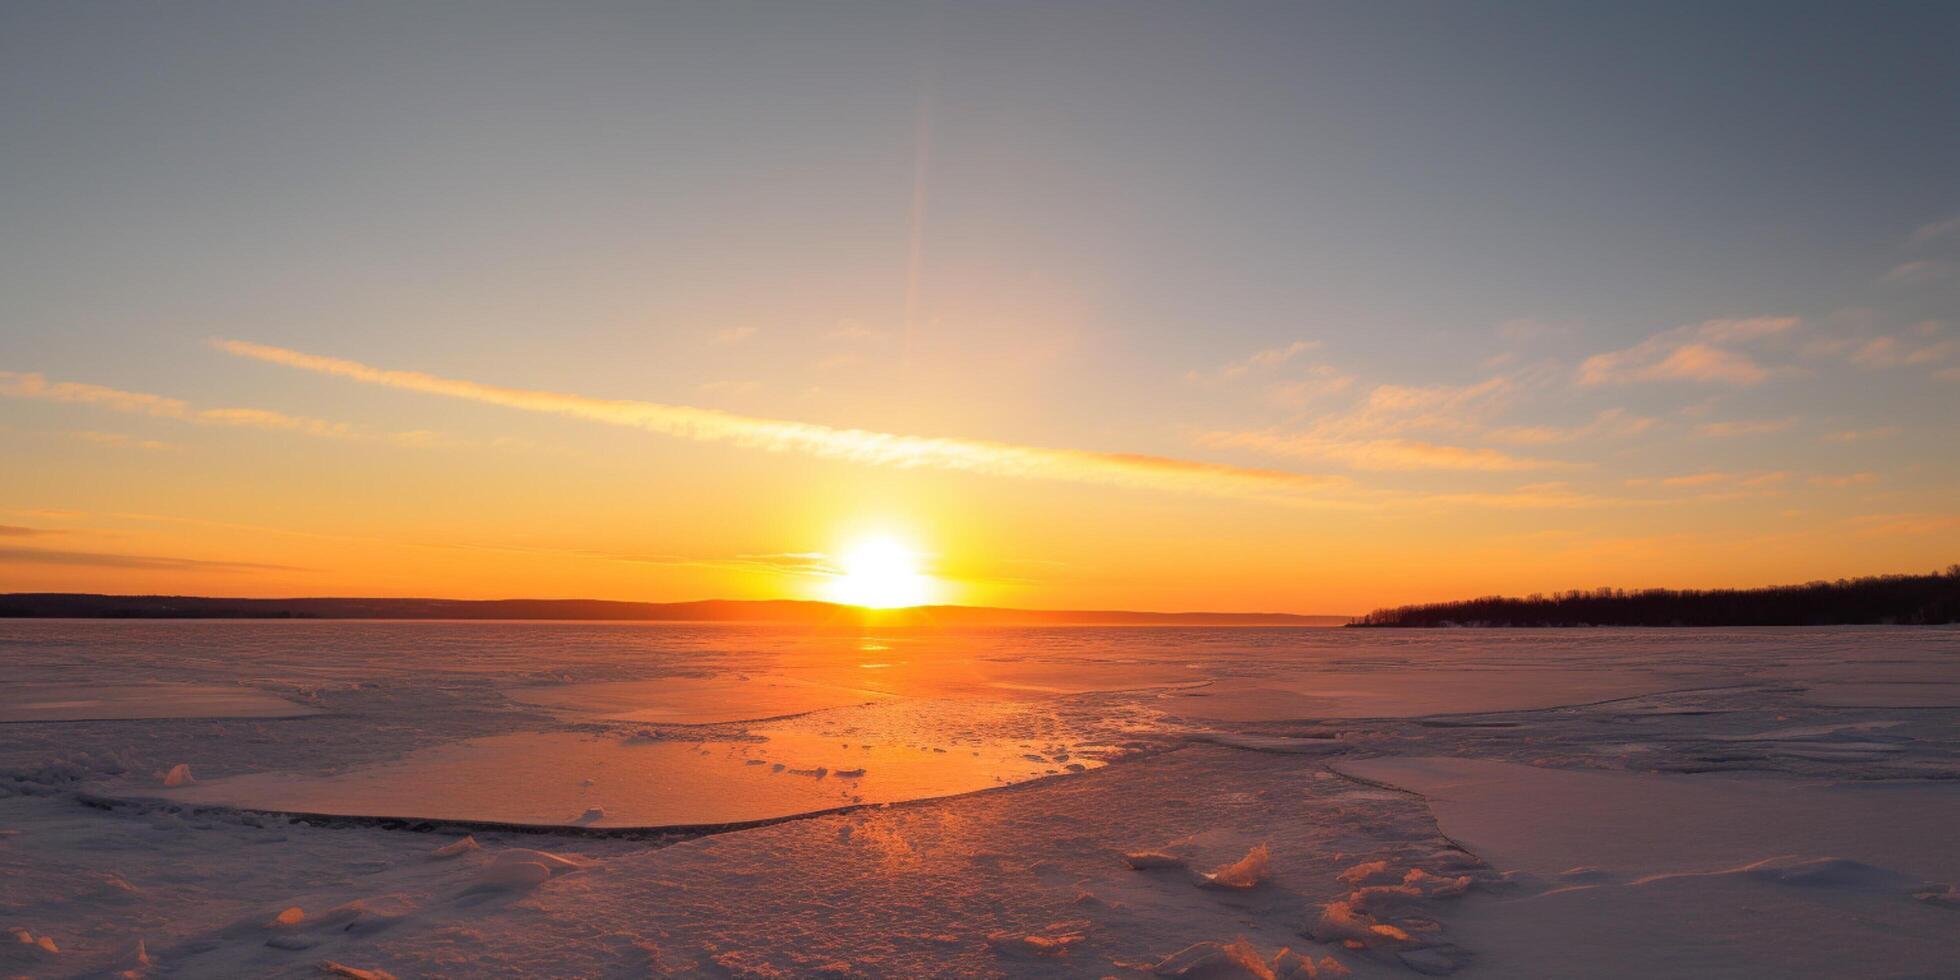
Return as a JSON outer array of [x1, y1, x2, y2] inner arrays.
[[0, 592, 1350, 627]]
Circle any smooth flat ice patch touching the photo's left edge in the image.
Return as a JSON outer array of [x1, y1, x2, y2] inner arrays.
[[0, 682, 319, 723]]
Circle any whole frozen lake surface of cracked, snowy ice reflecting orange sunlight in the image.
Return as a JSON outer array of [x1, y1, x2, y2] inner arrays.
[[0, 623, 1960, 978]]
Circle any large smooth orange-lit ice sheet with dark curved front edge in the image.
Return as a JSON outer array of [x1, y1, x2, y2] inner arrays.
[[157, 731, 1105, 827]]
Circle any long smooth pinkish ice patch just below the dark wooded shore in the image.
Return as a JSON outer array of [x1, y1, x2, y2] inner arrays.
[[1158, 666, 1723, 721]]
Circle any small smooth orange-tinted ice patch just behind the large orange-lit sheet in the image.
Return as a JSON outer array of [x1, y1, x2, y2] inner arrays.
[[504, 674, 890, 725]]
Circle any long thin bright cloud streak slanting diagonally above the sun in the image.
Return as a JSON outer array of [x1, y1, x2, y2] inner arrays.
[[212, 339, 1345, 502]]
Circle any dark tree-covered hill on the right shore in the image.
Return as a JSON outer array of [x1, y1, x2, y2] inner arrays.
[[1348, 564, 1960, 627]]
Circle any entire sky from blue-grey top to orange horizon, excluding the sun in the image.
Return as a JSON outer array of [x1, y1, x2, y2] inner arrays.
[[0, 0, 1960, 613]]
